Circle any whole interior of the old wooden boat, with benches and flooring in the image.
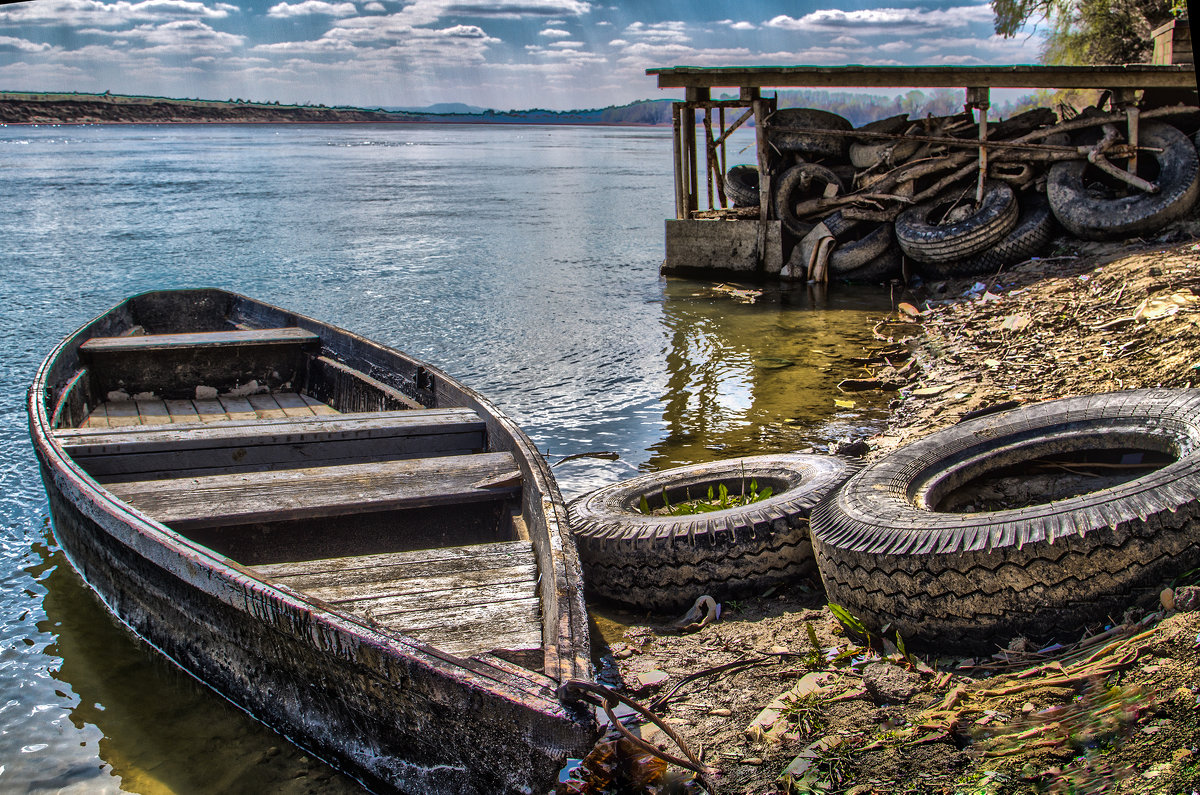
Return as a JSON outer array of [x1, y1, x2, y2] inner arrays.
[[46, 306, 542, 670]]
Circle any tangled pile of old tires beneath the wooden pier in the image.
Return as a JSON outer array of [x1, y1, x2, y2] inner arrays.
[[727, 108, 1200, 281]]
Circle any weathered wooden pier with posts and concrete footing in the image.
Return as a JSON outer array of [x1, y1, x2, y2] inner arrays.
[[647, 60, 1196, 279]]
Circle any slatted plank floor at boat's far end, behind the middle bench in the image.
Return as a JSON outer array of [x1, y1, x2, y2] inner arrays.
[[79, 393, 337, 428]]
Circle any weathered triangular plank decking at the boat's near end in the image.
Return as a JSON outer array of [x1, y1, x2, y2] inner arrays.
[[253, 540, 541, 664]]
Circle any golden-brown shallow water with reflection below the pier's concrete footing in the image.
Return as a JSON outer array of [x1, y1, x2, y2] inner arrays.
[[644, 280, 892, 470]]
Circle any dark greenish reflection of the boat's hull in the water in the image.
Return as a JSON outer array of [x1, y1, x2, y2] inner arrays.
[[35, 548, 361, 795]]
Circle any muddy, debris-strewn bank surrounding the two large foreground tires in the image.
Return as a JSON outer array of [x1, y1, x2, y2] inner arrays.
[[592, 235, 1200, 795]]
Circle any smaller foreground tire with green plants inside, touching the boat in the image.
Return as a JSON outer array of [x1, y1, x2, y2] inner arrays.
[[568, 454, 853, 611]]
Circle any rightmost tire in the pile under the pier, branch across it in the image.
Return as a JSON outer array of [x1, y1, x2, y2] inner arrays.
[[1046, 122, 1200, 240]]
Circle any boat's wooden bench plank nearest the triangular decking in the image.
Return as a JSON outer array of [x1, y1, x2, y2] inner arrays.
[[106, 453, 521, 531]]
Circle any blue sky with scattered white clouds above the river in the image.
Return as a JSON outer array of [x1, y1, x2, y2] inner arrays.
[[0, 0, 1040, 110]]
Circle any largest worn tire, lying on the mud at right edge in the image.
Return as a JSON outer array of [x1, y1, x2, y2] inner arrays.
[[812, 389, 1200, 652]]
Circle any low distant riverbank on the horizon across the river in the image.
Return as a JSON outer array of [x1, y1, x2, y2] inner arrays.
[[0, 92, 671, 127]]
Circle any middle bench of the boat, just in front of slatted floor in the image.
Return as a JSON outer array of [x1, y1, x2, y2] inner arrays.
[[54, 408, 485, 483]]
